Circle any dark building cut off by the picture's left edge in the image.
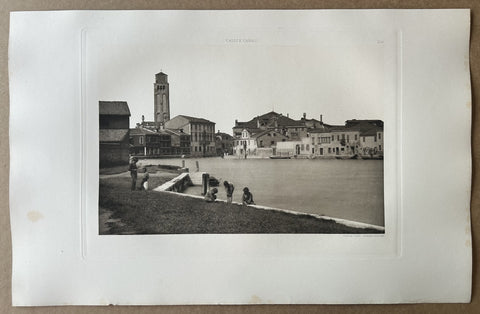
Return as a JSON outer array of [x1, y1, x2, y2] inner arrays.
[[98, 101, 130, 167]]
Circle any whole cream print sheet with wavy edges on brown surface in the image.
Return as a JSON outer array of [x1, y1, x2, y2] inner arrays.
[[9, 10, 472, 306]]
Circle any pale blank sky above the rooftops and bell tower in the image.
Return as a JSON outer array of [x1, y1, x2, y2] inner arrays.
[[91, 14, 386, 134]]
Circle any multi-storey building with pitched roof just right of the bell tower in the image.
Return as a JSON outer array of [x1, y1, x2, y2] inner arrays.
[[165, 115, 216, 156]]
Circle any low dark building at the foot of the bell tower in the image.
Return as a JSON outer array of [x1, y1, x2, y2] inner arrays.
[[130, 127, 172, 157]]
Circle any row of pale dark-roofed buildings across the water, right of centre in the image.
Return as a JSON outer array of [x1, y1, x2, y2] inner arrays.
[[238, 113, 384, 159]]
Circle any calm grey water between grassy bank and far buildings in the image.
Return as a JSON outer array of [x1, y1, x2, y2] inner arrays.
[[138, 158, 384, 226]]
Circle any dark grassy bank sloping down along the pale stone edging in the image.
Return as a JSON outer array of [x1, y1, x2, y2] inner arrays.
[[99, 173, 379, 234]]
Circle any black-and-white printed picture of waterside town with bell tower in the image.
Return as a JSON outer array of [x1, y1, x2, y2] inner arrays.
[[94, 36, 388, 235]]
